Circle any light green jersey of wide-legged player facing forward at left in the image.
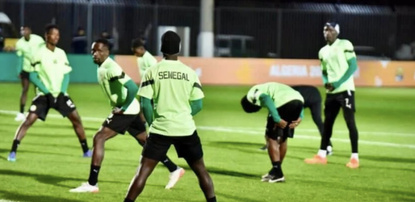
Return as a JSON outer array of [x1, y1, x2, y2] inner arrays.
[[31, 46, 72, 97]]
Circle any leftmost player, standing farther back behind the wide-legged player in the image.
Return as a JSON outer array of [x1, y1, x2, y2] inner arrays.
[[14, 25, 45, 121]]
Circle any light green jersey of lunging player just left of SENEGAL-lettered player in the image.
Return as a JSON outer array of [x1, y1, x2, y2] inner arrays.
[[97, 57, 140, 114]]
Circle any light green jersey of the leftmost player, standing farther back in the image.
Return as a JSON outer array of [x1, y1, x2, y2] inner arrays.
[[16, 34, 45, 72]]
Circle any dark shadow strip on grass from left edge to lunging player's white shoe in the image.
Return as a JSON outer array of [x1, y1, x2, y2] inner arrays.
[[0, 169, 125, 188]]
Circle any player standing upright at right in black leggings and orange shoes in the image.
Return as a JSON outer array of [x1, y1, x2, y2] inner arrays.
[[305, 22, 359, 168]]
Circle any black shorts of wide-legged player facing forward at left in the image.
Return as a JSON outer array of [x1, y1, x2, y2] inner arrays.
[[29, 95, 76, 121]]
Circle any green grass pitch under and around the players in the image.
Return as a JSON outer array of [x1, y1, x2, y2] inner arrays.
[[0, 83, 415, 202]]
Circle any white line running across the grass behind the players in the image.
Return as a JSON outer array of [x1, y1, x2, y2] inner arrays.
[[0, 110, 415, 149]]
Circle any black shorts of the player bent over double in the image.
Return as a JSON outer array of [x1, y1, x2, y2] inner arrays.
[[265, 100, 303, 142]]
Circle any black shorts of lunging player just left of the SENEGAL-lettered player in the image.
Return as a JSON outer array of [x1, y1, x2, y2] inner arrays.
[[102, 114, 146, 136]]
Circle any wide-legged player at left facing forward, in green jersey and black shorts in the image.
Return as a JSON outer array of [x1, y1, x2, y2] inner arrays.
[[7, 24, 92, 161]]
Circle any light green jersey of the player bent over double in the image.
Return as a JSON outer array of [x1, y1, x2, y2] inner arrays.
[[247, 82, 304, 108]]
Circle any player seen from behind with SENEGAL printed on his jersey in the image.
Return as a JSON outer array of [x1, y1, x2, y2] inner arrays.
[[124, 31, 216, 202]]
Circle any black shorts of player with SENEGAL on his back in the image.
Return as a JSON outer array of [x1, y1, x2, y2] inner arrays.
[[142, 130, 203, 163]]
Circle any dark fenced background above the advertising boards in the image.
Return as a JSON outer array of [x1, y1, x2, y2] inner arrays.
[[0, 0, 415, 60]]
